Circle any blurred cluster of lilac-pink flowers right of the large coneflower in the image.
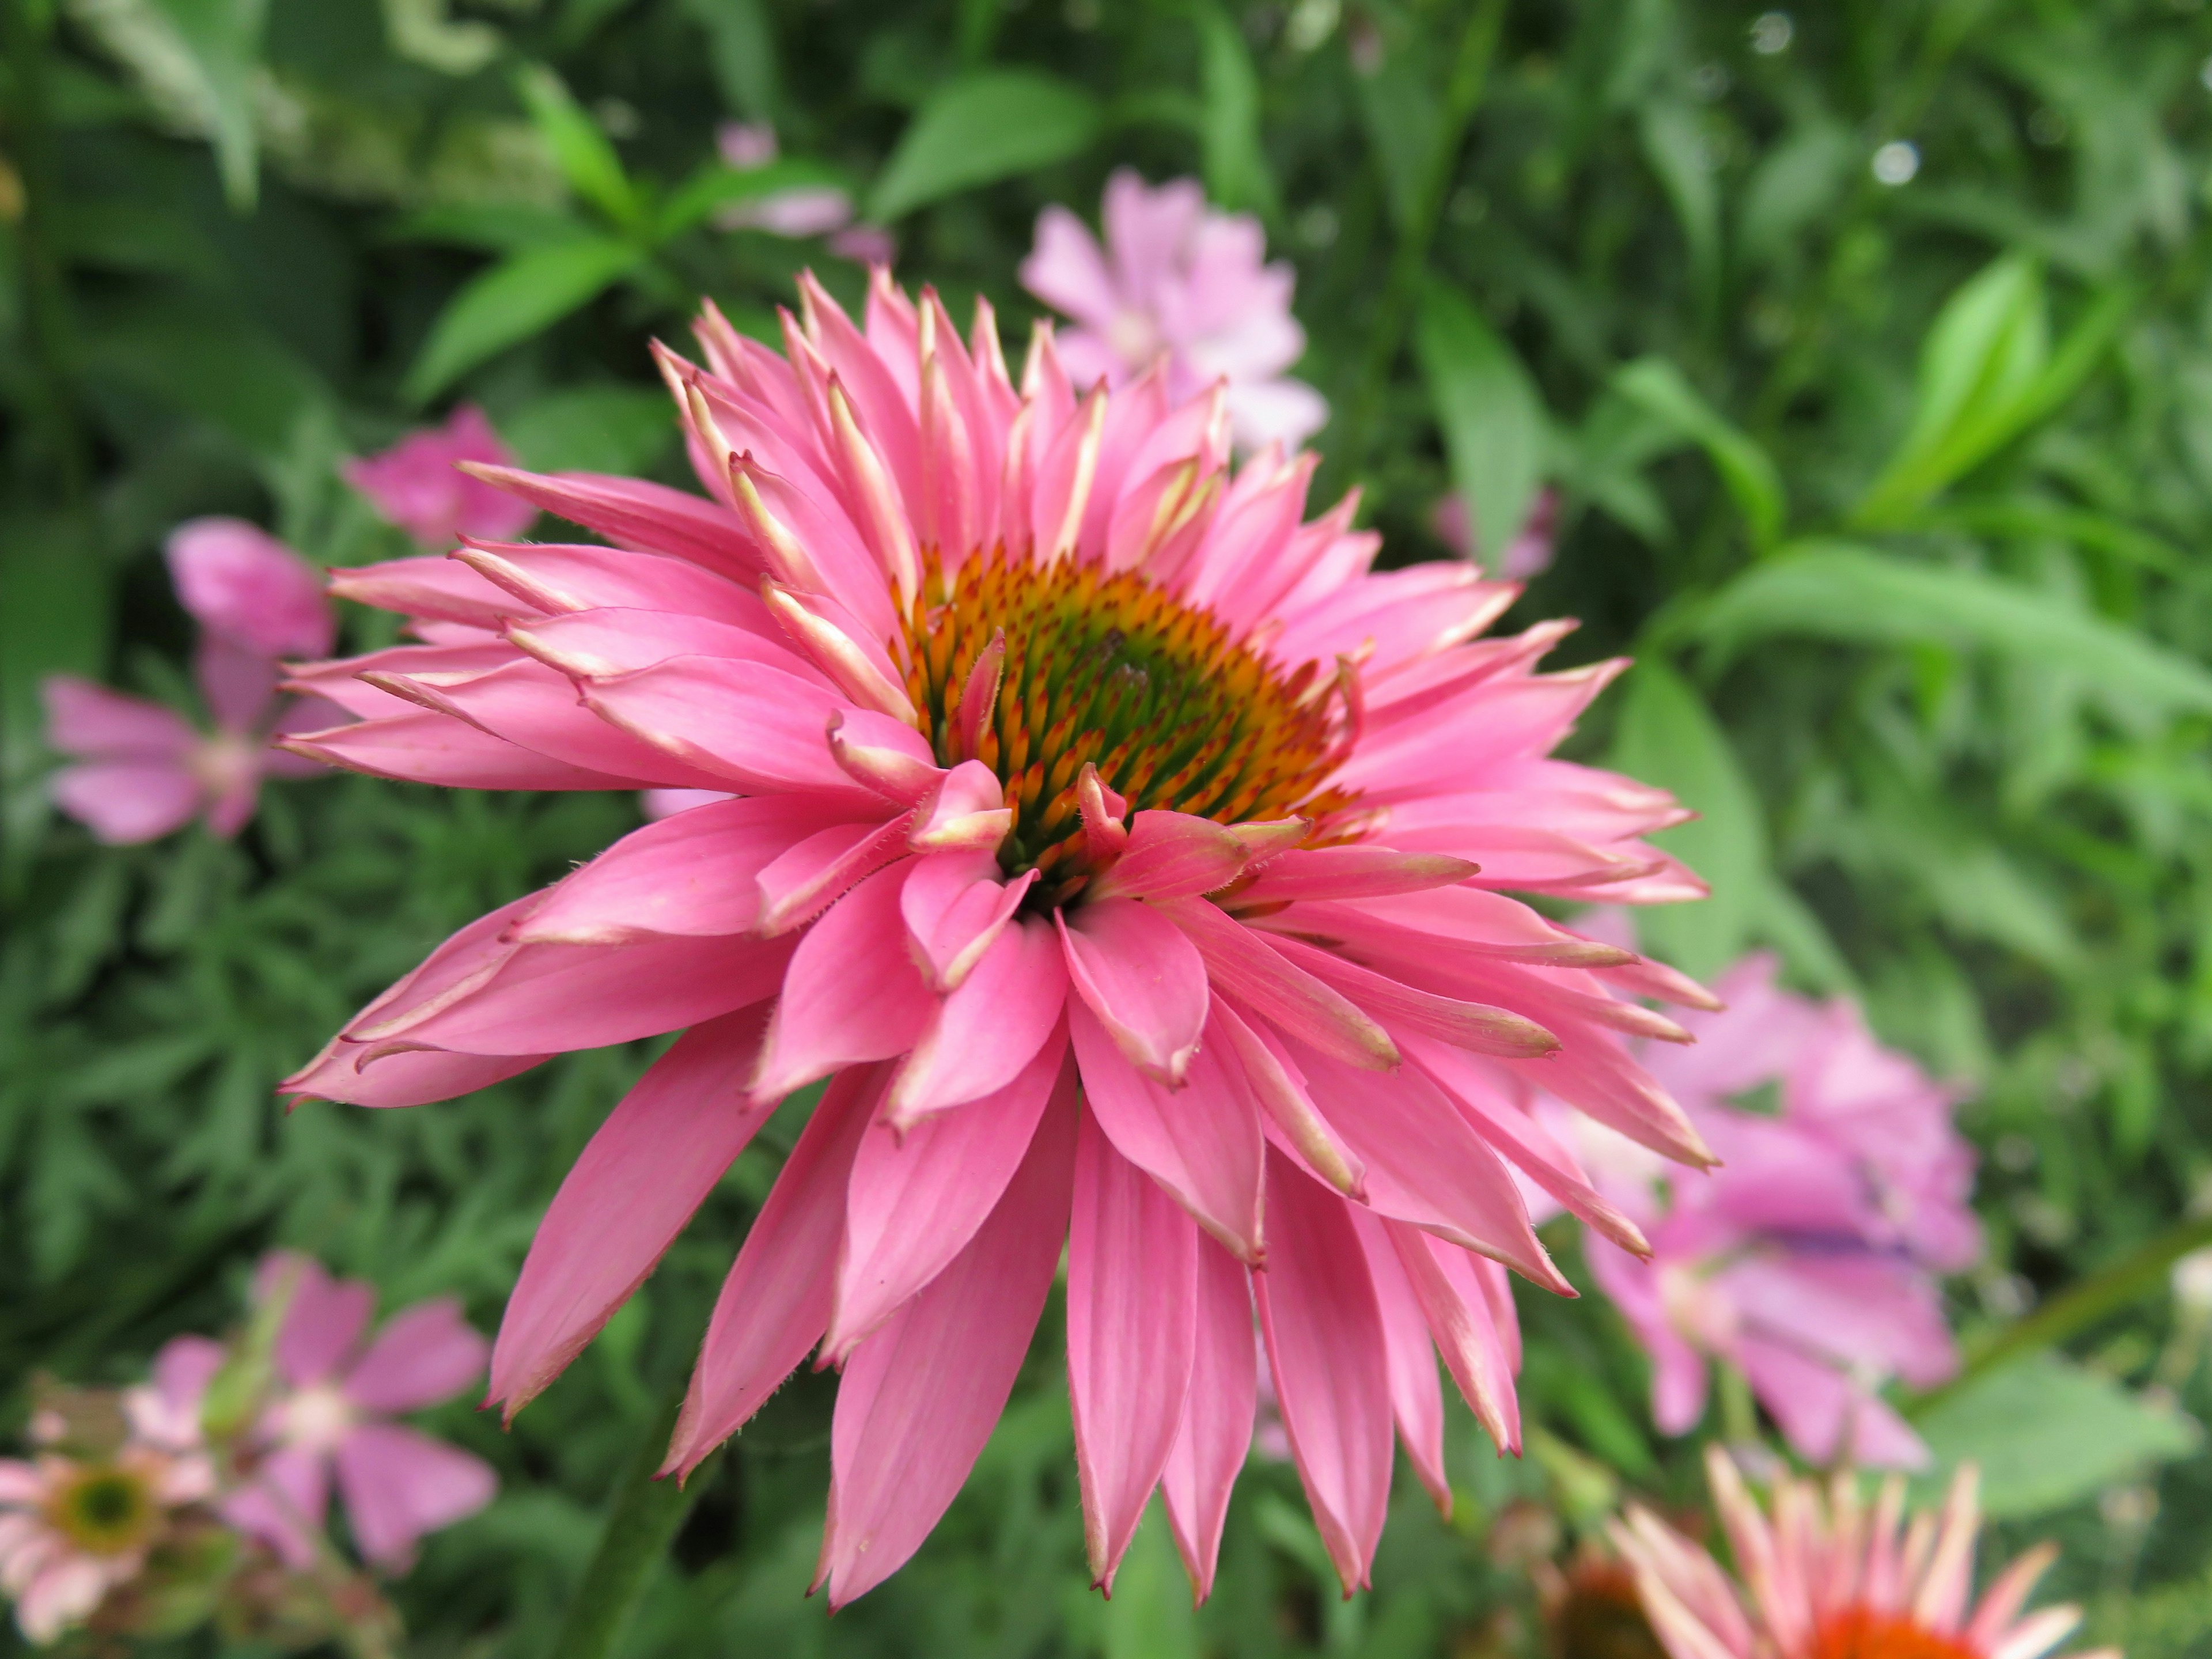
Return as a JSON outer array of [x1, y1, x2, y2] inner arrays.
[[1582, 956, 1982, 1469]]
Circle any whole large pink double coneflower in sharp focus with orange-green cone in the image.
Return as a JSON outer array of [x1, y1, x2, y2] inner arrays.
[[287, 272, 1707, 1601]]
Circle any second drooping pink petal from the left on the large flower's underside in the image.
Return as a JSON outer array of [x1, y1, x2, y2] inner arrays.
[[661, 1066, 885, 1475]]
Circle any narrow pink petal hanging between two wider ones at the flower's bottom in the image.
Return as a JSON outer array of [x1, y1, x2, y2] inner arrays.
[[1159, 1238, 1259, 1601]]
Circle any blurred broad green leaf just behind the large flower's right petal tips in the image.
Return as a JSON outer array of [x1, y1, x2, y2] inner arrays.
[[1606, 657, 1772, 978]]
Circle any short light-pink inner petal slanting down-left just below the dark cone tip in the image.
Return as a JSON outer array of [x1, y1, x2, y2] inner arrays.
[[885, 915, 1069, 1126]]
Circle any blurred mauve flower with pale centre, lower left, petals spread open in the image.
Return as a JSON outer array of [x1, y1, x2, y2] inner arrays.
[[221, 1252, 498, 1570]]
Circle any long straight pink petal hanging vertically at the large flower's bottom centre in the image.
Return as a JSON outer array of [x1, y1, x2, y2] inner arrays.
[[1069, 1113, 1199, 1590]]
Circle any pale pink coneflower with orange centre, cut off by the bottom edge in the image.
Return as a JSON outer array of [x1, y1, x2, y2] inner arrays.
[[1611, 1446, 2119, 1659]]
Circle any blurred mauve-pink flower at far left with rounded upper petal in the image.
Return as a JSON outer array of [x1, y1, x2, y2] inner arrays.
[[40, 518, 336, 845]]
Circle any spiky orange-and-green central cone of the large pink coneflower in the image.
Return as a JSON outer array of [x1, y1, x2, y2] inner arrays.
[[907, 551, 1356, 907]]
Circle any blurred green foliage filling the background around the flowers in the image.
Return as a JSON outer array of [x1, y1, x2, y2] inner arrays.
[[13, 0, 2212, 1659]]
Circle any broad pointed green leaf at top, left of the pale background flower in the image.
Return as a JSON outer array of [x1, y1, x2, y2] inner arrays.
[[867, 69, 1099, 224]]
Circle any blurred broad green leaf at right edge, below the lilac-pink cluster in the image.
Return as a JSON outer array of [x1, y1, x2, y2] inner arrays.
[[1914, 1354, 2203, 1520]]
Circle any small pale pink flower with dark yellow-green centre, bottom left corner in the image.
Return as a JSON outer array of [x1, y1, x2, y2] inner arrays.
[[0, 1435, 214, 1643]]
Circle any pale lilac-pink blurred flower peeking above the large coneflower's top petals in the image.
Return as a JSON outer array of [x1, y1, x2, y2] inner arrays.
[[1022, 168, 1330, 449]]
